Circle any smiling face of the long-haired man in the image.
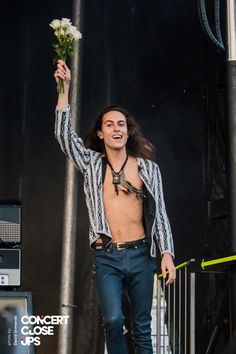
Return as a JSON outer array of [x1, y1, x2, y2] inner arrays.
[[98, 111, 128, 150]]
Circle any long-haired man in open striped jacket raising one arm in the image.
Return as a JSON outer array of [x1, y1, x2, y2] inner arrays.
[[54, 60, 175, 354]]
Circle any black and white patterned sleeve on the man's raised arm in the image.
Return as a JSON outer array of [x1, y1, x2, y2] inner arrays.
[[54, 107, 91, 173]]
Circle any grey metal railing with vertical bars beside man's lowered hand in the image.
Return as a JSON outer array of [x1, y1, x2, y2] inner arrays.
[[152, 260, 195, 354]]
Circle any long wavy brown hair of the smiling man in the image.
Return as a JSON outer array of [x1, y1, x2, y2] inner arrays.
[[84, 106, 156, 160]]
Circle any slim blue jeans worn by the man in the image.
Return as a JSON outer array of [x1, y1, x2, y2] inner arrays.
[[94, 244, 156, 354]]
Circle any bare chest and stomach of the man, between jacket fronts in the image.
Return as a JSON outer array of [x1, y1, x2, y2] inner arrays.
[[103, 157, 144, 242]]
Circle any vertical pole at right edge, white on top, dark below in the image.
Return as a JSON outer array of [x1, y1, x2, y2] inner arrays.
[[226, 0, 236, 334]]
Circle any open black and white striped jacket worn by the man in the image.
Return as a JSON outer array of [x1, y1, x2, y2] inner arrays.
[[55, 107, 174, 257]]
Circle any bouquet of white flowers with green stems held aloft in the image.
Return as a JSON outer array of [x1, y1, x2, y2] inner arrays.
[[49, 18, 82, 93]]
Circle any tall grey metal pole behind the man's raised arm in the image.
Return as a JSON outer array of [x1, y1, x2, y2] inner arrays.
[[57, 0, 82, 354]]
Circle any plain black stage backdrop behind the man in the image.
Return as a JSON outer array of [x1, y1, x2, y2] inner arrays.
[[0, 0, 228, 354]]
